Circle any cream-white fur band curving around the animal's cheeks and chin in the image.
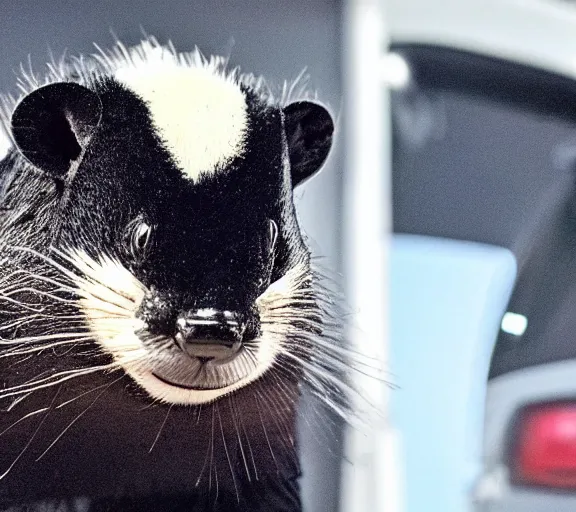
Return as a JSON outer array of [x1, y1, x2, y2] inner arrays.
[[65, 251, 305, 405]]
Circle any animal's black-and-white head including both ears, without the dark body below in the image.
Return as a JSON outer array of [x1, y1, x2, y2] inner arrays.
[[0, 41, 333, 404]]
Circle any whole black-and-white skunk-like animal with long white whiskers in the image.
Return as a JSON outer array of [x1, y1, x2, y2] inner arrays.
[[0, 38, 348, 511]]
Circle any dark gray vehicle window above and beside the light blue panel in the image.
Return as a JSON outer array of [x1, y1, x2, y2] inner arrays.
[[392, 46, 576, 377]]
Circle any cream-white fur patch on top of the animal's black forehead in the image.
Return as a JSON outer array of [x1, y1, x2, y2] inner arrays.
[[114, 47, 248, 180]]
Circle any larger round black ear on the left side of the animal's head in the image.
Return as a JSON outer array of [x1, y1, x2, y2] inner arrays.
[[12, 82, 102, 178]]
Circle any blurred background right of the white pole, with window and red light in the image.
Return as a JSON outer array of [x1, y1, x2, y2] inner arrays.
[[382, 0, 576, 512]]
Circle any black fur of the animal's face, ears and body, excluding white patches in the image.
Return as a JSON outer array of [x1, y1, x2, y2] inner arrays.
[[0, 46, 333, 511]]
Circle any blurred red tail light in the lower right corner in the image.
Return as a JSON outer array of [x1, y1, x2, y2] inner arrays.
[[510, 403, 576, 490]]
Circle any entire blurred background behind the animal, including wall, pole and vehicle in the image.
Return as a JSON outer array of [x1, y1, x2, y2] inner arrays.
[[5, 0, 576, 512]]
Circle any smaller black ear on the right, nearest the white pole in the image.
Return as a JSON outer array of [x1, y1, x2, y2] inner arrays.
[[284, 101, 334, 187]]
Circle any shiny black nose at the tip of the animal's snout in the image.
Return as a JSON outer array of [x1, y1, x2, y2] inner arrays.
[[175, 308, 246, 358]]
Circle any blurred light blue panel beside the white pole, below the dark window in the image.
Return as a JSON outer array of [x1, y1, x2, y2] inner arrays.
[[390, 235, 516, 512]]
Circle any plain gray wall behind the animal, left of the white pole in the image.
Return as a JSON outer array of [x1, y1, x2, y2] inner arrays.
[[0, 0, 341, 512]]
